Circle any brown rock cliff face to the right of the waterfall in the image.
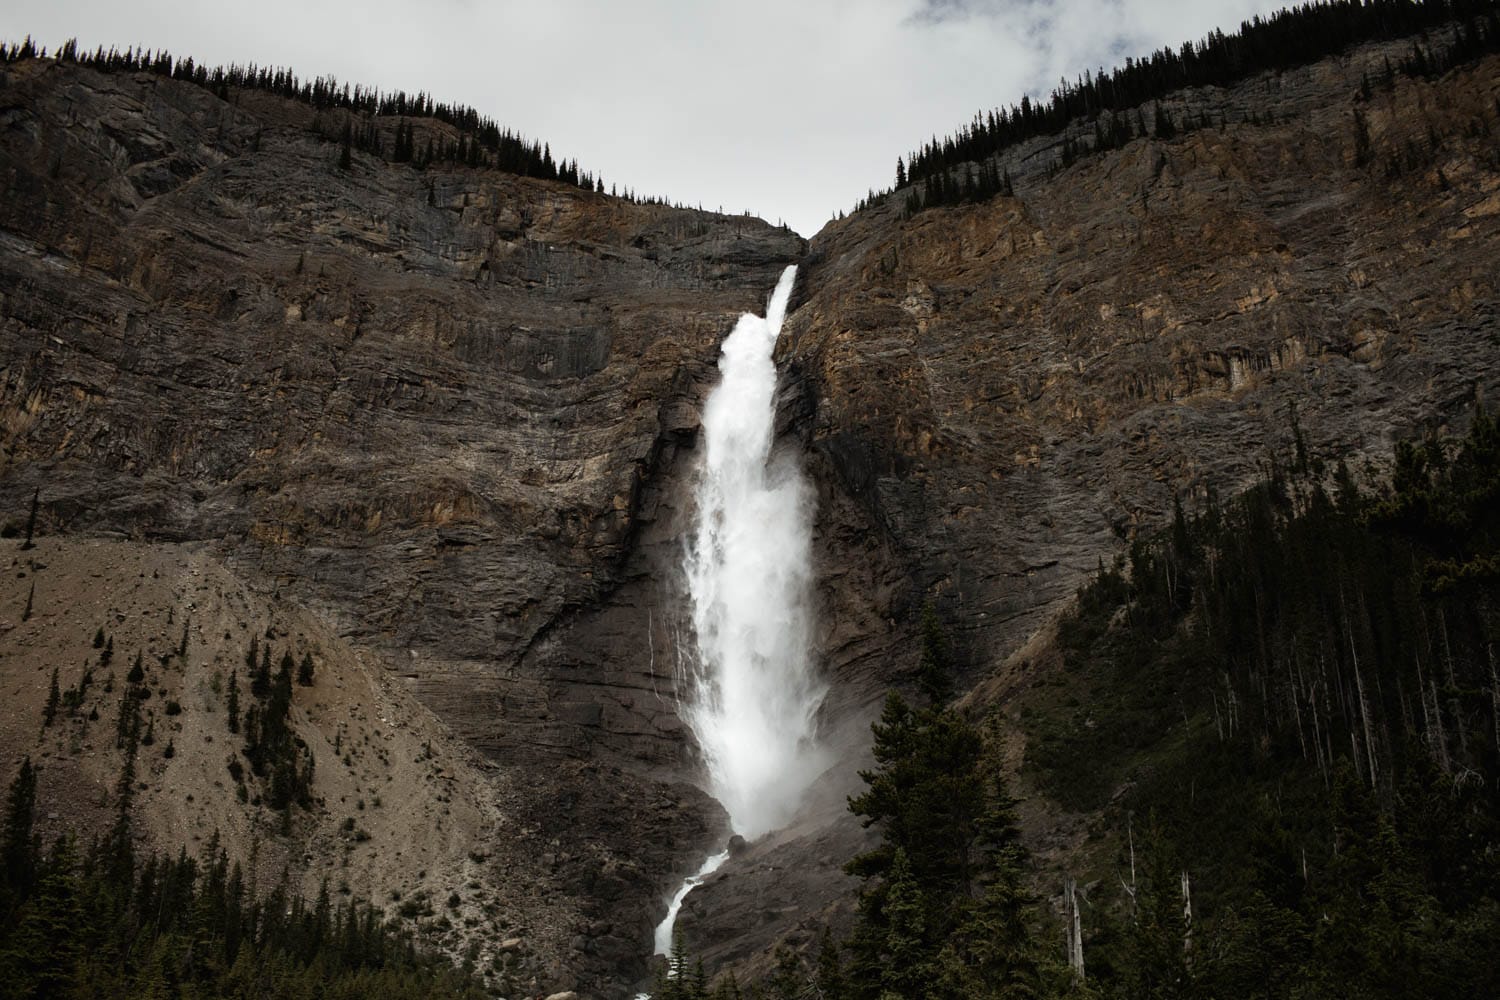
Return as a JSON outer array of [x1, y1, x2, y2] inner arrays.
[[683, 39, 1500, 970]]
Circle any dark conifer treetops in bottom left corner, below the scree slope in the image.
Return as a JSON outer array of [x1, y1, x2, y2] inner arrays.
[[0, 803, 485, 1000]]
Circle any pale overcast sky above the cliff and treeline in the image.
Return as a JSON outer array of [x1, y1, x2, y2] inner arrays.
[[0, 0, 1284, 235]]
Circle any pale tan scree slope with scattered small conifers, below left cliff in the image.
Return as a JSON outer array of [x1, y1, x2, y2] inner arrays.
[[0, 537, 585, 990]]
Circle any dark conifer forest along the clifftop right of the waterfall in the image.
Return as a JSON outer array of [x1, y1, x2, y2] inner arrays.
[[861, 0, 1500, 213]]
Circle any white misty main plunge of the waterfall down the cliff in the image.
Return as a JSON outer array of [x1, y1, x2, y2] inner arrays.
[[684, 267, 827, 840]]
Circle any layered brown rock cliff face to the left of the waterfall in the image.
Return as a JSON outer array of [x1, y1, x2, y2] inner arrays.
[[0, 61, 804, 996]]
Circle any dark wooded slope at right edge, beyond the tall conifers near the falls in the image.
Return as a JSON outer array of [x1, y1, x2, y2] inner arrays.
[[1023, 412, 1500, 997]]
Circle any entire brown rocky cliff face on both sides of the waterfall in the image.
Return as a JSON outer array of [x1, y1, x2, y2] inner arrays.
[[0, 31, 1500, 996]]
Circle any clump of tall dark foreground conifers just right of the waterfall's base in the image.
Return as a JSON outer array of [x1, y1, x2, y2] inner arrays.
[[846, 691, 1041, 1000]]
